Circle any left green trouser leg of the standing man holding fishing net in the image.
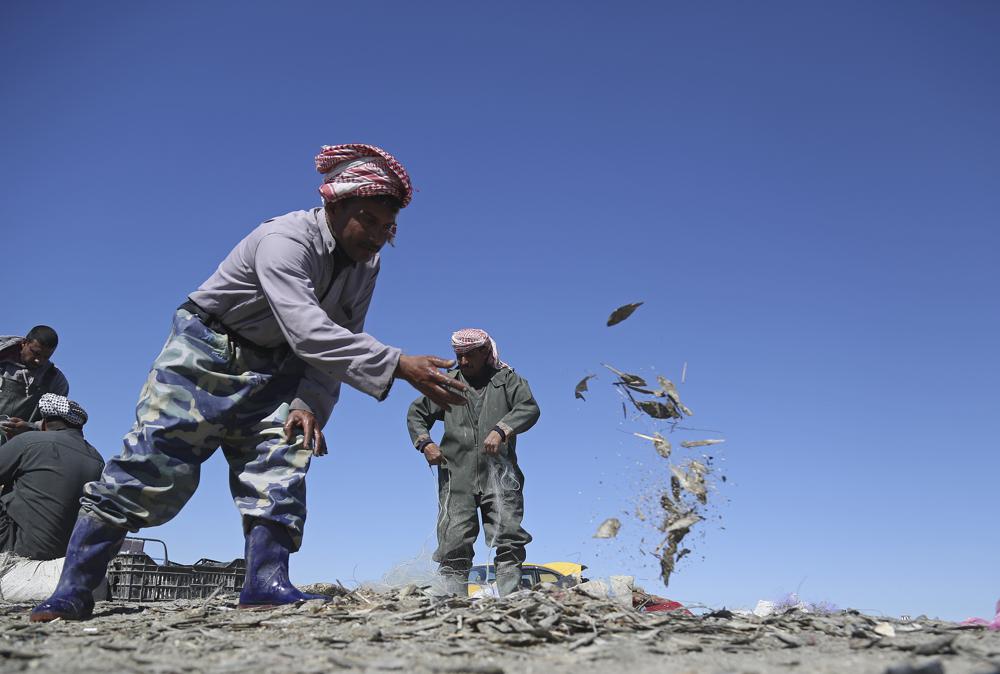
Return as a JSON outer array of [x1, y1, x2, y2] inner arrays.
[[433, 466, 479, 597]]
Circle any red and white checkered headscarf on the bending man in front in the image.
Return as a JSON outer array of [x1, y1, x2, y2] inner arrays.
[[316, 143, 413, 207]]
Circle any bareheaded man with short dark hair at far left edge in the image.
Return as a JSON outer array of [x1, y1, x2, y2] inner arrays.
[[0, 325, 69, 443]]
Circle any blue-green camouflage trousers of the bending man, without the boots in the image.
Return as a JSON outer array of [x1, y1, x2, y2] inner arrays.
[[83, 307, 312, 550]]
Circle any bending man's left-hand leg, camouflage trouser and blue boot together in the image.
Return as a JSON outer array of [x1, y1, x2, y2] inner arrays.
[[33, 310, 270, 619]]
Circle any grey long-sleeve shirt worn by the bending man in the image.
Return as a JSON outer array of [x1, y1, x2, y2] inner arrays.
[[190, 208, 400, 424]]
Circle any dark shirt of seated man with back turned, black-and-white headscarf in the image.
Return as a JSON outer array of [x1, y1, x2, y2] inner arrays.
[[0, 429, 104, 560]]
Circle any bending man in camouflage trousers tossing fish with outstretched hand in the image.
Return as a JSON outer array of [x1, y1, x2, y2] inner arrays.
[[31, 145, 464, 622]]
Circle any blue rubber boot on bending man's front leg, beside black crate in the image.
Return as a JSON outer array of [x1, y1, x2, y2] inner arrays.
[[240, 520, 330, 608]]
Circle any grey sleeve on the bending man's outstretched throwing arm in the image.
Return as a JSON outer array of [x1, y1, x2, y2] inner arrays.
[[254, 234, 400, 400]]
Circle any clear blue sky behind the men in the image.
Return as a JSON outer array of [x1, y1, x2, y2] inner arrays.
[[0, 0, 1000, 619]]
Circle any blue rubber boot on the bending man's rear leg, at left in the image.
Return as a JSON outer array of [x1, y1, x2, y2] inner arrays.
[[31, 514, 127, 623]]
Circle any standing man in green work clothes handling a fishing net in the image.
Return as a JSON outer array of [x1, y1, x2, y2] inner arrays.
[[406, 328, 539, 597]]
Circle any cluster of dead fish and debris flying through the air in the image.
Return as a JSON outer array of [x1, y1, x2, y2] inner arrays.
[[574, 302, 723, 585]]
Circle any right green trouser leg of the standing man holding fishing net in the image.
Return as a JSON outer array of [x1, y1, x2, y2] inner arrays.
[[480, 458, 531, 597]]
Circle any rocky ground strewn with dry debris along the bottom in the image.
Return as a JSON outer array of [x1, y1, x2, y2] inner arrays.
[[0, 586, 1000, 674]]
